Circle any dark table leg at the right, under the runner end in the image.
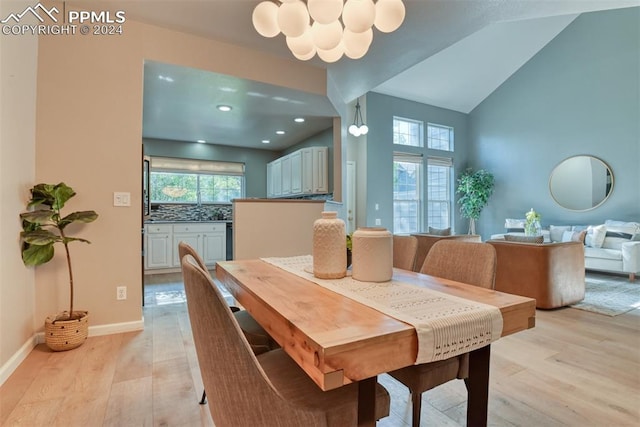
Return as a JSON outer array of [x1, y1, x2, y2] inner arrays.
[[466, 345, 491, 427]]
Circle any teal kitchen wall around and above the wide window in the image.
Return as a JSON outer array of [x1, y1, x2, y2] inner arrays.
[[143, 139, 281, 197]]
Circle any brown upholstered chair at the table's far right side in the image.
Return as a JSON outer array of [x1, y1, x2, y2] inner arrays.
[[389, 240, 497, 427]]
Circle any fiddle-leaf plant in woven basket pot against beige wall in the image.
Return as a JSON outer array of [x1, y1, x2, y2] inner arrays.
[[20, 182, 98, 351]]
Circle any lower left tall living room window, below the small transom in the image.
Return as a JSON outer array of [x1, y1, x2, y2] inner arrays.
[[393, 154, 422, 234]]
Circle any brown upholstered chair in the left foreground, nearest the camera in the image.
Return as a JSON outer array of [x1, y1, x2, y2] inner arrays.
[[182, 255, 389, 427]]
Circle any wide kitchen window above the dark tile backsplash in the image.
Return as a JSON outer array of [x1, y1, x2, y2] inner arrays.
[[150, 157, 244, 203]]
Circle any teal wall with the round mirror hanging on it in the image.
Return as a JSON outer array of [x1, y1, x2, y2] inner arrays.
[[469, 7, 640, 238]]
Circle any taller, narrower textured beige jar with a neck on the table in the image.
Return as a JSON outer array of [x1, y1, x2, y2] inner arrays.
[[313, 211, 347, 279]]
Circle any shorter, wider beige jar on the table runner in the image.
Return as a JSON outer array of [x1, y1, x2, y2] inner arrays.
[[351, 227, 393, 282]]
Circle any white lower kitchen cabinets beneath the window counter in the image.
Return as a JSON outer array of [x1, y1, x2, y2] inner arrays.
[[145, 222, 227, 270]]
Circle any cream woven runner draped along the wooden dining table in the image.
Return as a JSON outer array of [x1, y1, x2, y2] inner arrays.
[[261, 255, 502, 364]]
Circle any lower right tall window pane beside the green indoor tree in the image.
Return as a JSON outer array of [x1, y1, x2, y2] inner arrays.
[[427, 157, 453, 228]]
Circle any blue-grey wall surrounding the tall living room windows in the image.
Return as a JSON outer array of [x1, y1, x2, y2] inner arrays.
[[364, 92, 469, 234]]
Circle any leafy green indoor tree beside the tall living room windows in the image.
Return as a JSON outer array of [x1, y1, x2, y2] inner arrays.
[[456, 168, 494, 234]]
